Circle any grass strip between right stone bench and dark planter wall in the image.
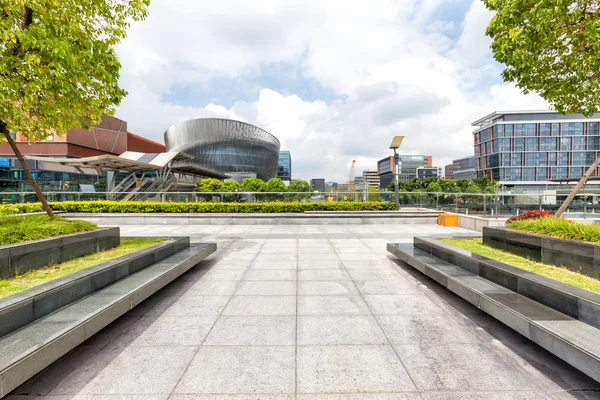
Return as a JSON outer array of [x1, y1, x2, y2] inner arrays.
[[440, 239, 600, 294]]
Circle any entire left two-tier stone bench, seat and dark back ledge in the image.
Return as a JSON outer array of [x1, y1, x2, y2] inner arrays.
[[0, 237, 216, 398]]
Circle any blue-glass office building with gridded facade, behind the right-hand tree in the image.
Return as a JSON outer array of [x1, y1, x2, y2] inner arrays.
[[472, 111, 600, 183]]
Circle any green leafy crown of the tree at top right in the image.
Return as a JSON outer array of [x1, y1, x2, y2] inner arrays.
[[484, 0, 600, 116]]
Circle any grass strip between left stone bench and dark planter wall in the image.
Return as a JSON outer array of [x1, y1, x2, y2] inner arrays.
[[0, 238, 164, 298]]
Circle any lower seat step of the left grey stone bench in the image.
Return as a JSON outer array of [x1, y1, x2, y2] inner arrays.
[[0, 243, 216, 398]]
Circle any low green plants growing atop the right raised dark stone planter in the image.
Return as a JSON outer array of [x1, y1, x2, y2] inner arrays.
[[507, 217, 600, 243]]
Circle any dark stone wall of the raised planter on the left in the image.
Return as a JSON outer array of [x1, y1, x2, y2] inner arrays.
[[0, 228, 120, 279]]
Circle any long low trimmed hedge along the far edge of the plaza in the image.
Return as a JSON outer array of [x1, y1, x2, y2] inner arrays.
[[0, 200, 394, 214]]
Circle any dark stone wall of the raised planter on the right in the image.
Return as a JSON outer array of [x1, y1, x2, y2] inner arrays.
[[483, 227, 600, 279]]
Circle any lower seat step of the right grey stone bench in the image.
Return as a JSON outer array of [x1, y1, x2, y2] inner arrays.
[[387, 238, 600, 382]]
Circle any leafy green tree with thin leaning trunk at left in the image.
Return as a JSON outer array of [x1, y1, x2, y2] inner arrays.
[[0, 0, 150, 216]]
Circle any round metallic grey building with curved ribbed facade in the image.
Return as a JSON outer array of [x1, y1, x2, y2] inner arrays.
[[165, 118, 280, 181]]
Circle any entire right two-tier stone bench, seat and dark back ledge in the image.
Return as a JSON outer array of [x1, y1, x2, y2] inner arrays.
[[387, 237, 600, 382]]
